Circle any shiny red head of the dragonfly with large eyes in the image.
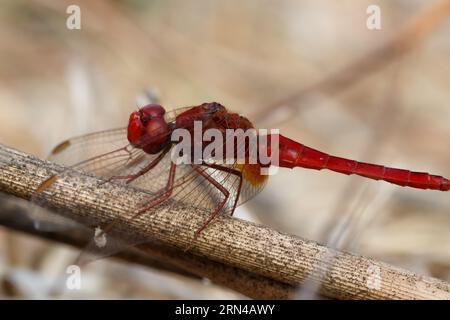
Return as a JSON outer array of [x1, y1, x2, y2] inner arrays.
[[128, 104, 170, 154]]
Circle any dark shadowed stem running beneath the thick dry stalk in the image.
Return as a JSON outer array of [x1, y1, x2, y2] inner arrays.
[[0, 182, 295, 299]]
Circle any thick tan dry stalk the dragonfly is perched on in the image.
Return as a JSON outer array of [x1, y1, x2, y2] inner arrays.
[[0, 145, 450, 299]]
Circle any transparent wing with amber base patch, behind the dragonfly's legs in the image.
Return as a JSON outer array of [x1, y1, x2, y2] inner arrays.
[[77, 155, 267, 265]]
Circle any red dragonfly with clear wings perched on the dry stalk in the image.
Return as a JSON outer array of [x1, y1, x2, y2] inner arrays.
[[38, 102, 450, 242]]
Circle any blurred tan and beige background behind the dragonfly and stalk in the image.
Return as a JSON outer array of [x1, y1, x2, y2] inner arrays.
[[0, 0, 450, 299]]
